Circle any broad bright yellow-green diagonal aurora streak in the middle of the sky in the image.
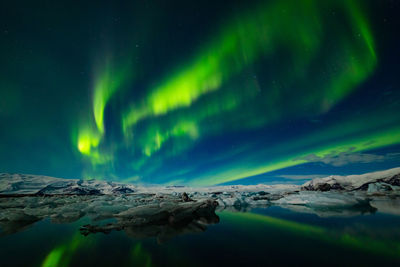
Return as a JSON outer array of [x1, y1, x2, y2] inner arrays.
[[123, 0, 318, 131]]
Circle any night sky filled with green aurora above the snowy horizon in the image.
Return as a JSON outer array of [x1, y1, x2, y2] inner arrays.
[[0, 0, 400, 186]]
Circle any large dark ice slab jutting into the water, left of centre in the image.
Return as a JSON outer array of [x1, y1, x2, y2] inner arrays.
[[80, 199, 219, 243]]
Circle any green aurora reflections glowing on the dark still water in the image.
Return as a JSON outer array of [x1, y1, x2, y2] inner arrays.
[[41, 211, 400, 267]]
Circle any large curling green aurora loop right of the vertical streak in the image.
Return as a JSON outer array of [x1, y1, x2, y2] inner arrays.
[[122, 1, 376, 157]]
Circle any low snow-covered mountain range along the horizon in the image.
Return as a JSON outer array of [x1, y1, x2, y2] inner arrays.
[[0, 167, 400, 195]]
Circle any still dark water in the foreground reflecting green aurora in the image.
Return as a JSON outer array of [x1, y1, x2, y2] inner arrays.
[[0, 207, 400, 266]]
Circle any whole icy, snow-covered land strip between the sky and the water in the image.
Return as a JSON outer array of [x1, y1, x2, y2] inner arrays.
[[0, 168, 400, 232]]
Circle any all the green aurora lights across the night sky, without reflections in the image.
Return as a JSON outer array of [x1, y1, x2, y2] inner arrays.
[[73, 0, 400, 185]]
